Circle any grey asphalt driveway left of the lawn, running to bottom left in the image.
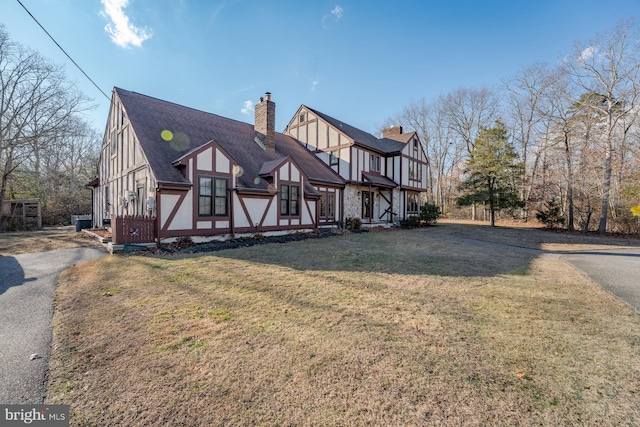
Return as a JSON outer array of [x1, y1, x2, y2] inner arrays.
[[0, 246, 106, 404]]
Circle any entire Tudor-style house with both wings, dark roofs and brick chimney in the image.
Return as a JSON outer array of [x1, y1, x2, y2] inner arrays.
[[91, 88, 426, 241]]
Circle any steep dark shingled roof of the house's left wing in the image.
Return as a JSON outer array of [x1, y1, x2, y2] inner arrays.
[[114, 88, 344, 190]]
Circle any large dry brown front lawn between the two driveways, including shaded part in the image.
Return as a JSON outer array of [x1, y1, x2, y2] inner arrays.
[[47, 226, 640, 426]]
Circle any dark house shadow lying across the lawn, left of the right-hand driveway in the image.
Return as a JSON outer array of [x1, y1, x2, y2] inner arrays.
[[190, 230, 542, 277]]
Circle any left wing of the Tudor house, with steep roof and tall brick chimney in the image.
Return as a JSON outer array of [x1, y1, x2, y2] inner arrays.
[[93, 88, 344, 240]]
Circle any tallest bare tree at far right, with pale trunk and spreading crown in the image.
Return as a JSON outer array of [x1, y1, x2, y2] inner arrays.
[[563, 20, 640, 233]]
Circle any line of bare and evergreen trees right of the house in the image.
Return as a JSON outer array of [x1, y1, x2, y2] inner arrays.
[[387, 19, 640, 233]]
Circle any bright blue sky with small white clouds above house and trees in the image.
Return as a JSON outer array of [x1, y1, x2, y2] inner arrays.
[[0, 0, 640, 133]]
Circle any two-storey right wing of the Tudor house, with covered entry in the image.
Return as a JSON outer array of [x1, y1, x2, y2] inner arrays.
[[284, 105, 429, 223]]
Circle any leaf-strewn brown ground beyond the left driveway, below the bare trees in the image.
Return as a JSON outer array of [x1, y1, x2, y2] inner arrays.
[[0, 227, 96, 255]]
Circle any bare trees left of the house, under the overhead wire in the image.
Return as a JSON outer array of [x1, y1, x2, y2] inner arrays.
[[0, 24, 101, 231]]
